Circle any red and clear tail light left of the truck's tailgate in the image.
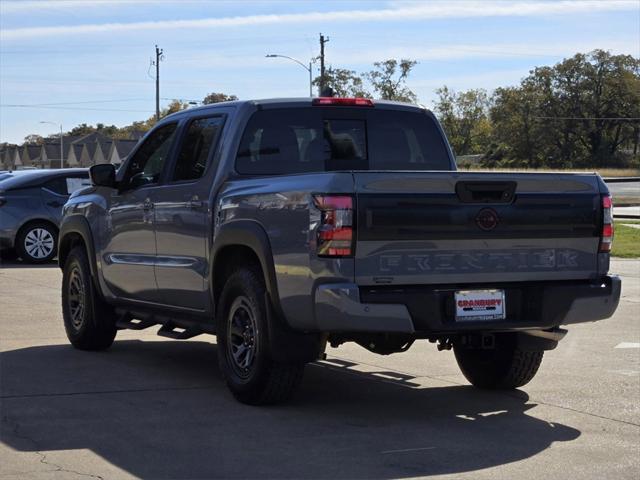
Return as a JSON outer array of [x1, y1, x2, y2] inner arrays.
[[313, 195, 355, 257]]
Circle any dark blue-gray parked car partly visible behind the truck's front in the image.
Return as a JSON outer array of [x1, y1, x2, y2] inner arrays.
[[0, 169, 90, 263]]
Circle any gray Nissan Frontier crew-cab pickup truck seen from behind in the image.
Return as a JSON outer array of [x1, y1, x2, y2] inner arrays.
[[58, 97, 620, 404]]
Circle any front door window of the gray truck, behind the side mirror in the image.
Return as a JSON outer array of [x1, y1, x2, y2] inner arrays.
[[126, 123, 178, 188]]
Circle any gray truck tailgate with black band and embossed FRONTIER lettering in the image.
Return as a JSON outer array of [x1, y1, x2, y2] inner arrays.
[[354, 172, 601, 285]]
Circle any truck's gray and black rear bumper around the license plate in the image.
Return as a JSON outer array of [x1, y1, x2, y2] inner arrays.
[[314, 276, 621, 336]]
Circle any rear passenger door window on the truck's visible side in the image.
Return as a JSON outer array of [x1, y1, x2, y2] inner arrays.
[[171, 117, 223, 182]]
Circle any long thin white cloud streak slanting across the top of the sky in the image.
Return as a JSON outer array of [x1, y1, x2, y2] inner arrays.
[[0, 0, 638, 41]]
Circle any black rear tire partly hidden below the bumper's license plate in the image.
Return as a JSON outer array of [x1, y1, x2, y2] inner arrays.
[[454, 334, 544, 389]]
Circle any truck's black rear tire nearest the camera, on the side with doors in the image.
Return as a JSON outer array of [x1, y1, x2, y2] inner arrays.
[[217, 267, 304, 405]]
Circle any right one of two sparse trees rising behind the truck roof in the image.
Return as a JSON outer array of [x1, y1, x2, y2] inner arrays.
[[364, 59, 418, 103]]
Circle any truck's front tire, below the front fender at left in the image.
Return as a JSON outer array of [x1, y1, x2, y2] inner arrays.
[[62, 247, 116, 350]]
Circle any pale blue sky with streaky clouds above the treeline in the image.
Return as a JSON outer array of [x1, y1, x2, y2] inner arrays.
[[0, 0, 640, 143]]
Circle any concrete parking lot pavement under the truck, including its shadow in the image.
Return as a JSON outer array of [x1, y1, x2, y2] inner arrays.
[[0, 260, 640, 479]]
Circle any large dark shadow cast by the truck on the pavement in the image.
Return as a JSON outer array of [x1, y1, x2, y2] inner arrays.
[[0, 340, 580, 479]]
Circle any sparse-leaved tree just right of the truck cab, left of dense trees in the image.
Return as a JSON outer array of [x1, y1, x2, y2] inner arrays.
[[433, 85, 492, 155]]
